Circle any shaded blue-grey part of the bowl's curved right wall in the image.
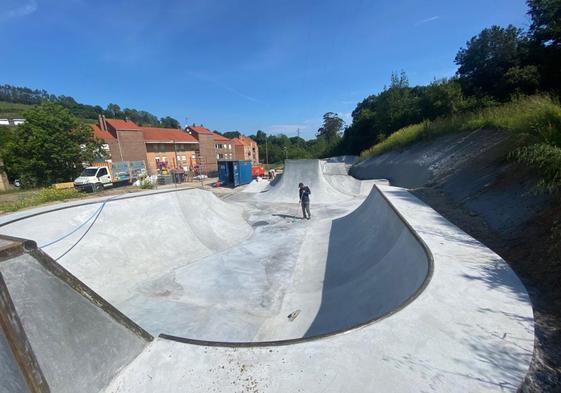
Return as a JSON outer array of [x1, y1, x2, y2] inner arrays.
[[305, 187, 431, 337]]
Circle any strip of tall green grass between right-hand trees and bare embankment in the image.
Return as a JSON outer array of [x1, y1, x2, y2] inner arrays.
[[360, 96, 561, 159]]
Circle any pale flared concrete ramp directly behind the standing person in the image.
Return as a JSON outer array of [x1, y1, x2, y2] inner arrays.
[[259, 160, 351, 203]]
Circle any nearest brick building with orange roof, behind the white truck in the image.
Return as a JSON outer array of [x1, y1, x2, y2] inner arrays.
[[91, 116, 199, 175]]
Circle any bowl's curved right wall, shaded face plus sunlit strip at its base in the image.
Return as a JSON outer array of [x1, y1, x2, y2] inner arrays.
[[255, 187, 432, 341]]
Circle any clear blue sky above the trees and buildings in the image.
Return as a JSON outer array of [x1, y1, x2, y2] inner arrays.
[[0, 0, 529, 138]]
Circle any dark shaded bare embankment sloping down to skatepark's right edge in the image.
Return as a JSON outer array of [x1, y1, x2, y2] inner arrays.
[[350, 130, 561, 392]]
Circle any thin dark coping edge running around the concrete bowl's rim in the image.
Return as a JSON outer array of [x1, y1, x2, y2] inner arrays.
[[0, 184, 434, 348]]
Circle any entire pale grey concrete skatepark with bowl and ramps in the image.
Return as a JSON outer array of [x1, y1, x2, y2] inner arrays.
[[0, 159, 534, 392]]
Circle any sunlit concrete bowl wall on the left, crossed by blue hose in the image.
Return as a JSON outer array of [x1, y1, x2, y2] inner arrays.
[[0, 190, 252, 306]]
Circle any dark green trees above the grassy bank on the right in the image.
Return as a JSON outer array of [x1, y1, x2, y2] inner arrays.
[[330, 0, 561, 154]]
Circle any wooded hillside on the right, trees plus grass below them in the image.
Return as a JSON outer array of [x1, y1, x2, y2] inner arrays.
[[332, 0, 561, 191]]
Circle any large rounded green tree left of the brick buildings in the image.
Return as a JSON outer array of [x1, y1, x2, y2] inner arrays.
[[3, 102, 104, 187]]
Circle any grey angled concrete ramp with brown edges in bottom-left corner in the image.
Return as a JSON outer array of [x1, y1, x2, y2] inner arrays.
[[0, 237, 152, 393]]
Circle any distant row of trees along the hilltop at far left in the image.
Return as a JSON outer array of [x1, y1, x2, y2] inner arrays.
[[0, 84, 180, 128]]
